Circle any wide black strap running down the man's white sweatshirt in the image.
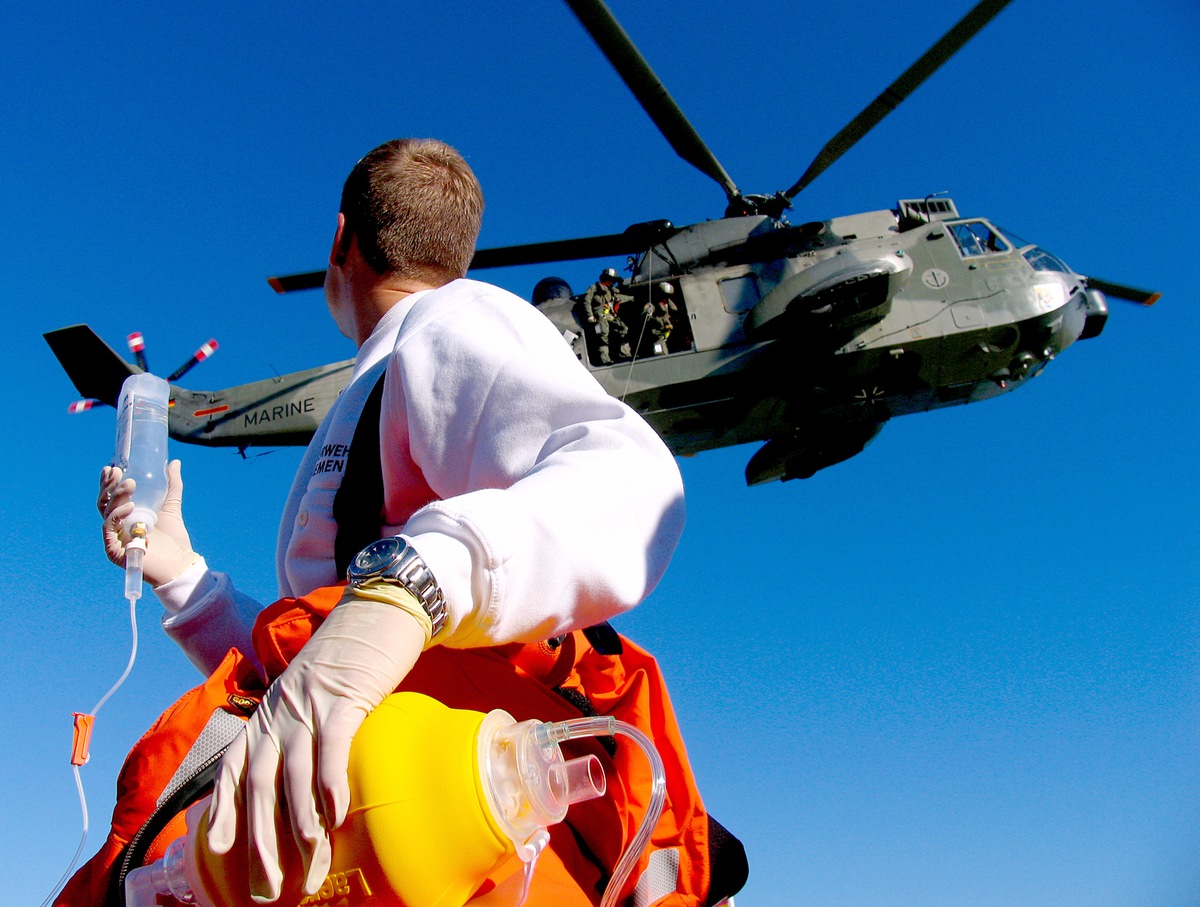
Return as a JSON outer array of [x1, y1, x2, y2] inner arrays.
[[334, 372, 386, 577]]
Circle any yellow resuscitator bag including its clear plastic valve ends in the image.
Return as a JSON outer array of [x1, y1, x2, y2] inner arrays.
[[125, 692, 605, 907]]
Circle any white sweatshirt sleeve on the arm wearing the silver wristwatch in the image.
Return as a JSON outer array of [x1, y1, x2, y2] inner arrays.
[[382, 281, 684, 647]]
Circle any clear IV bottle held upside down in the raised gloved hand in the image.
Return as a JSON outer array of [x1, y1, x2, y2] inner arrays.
[[113, 373, 170, 601]]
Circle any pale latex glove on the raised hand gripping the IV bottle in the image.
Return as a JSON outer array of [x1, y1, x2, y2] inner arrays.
[[96, 459, 197, 585]]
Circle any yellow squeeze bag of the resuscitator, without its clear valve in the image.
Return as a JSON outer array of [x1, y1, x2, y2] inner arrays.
[[188, 692, 521, 907]]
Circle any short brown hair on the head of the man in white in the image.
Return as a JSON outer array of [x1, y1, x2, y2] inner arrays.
[[342, 139, 484, 286]]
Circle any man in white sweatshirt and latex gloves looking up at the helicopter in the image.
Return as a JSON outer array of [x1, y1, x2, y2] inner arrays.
[[100, 139, 683, 901]]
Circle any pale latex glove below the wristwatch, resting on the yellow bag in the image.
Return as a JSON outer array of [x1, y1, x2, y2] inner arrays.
[[209, 593, 426, 903]]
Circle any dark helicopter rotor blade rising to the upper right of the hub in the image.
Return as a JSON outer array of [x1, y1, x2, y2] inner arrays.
[[784, 0, 1012, 198]]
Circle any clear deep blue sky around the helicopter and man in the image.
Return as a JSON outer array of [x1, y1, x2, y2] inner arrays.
[[0, 0, 1200, 907]]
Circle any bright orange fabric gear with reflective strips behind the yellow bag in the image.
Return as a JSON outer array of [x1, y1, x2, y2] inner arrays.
[[63, 585, 746, 907]]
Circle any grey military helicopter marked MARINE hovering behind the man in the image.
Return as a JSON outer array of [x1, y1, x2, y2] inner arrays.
[[46, 0, 1158, 485]]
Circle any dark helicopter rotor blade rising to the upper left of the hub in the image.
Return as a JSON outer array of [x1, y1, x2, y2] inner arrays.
[[566, 0, 742, 204]]
